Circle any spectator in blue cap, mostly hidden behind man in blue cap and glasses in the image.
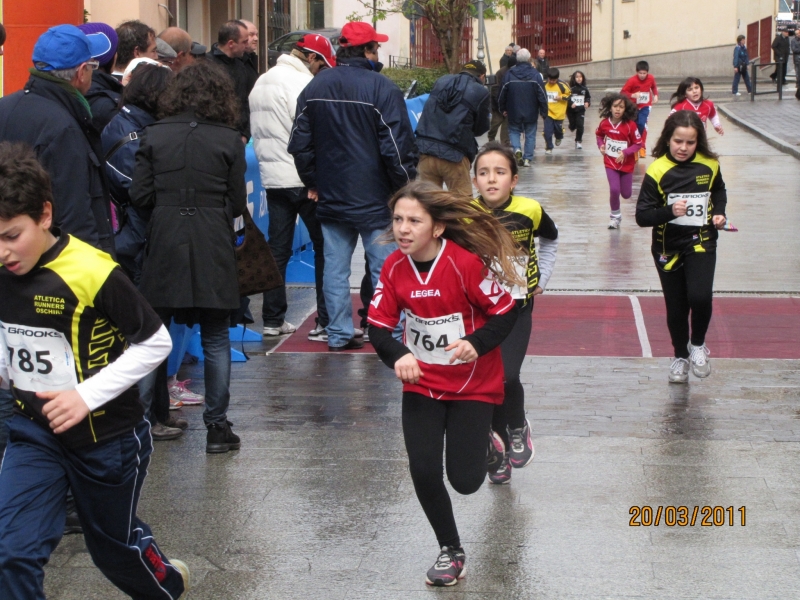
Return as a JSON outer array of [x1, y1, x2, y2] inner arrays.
[[78, 23, 122, 131]]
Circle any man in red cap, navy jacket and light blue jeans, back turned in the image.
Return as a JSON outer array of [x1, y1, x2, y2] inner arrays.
[[289, 22, 417, 351]]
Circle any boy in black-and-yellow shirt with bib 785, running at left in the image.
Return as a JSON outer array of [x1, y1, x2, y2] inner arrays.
[[0, 143, 189, 599]]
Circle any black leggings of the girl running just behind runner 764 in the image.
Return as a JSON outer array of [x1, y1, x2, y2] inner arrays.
[[492, 298, 533, 448]]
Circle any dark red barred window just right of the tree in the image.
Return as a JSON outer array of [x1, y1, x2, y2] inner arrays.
[[515, 0, 592, 66]]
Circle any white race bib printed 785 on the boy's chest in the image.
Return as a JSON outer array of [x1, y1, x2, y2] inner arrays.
[[0, 323, 78, 392]]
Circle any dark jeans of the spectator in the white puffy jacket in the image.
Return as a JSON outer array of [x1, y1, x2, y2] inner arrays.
[[261, 188, 328, 327]]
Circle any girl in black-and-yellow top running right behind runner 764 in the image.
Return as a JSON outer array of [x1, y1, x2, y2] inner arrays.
[[472, 142, 558, 483]]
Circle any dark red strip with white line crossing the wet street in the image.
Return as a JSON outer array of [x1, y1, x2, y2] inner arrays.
[[275, 294, 800, 359]]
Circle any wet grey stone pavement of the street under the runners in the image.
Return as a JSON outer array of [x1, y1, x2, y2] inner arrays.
[[45, 107, 800, 600]]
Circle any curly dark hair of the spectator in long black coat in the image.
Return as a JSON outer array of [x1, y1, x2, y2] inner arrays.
[[158, 60, 239, 127]]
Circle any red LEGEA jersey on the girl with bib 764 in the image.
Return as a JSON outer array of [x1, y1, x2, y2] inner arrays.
[[368, 239, 514, 404]]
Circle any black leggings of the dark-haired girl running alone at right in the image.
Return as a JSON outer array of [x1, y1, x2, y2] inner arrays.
[[656, 252, 717, 358]]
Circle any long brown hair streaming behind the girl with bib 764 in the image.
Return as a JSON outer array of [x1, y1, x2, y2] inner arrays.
[[389, 181, 525, 285]]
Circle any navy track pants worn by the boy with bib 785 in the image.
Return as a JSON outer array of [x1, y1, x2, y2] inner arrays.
[[0, 415, 183, 600]]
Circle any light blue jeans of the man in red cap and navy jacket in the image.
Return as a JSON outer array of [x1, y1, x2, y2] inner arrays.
[[322, 221, 397, 348]]
